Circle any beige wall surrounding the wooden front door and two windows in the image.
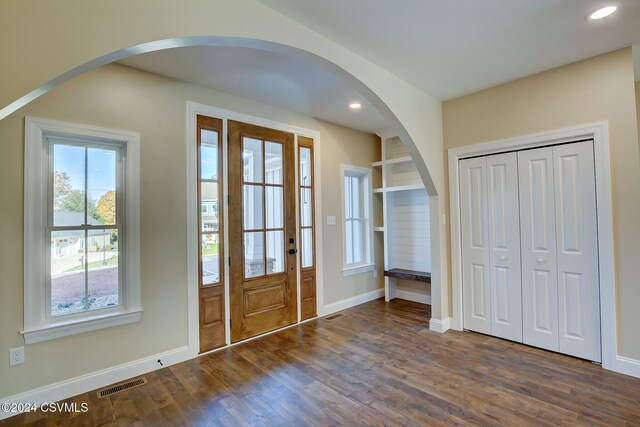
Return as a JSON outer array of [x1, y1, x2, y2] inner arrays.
[[0, 65, 383, 400]]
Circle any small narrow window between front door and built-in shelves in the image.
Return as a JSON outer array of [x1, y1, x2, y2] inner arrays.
[[342, 165, 374, 275]]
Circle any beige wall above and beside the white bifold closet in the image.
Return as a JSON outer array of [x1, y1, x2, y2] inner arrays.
[[443, 48, 640, 359]]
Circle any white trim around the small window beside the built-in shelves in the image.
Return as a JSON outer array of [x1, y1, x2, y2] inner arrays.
[[340, 164, 376, 277]]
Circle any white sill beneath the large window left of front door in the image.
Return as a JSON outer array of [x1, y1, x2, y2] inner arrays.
[[20, 308, 142, 344]]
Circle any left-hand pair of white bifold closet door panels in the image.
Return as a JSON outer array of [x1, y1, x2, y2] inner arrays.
[[460, 153, 522, 342]]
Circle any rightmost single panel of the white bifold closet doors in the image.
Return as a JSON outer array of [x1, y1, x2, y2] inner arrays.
[[553, 141, 601, 362]]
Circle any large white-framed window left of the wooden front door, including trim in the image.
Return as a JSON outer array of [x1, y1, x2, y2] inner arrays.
[[23, 117, 141, 343]]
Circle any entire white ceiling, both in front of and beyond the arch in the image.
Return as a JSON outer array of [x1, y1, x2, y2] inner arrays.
[[120, 0, 640, 132]]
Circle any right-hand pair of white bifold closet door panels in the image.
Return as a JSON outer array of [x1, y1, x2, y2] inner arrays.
[[518, 141, 601, 361]]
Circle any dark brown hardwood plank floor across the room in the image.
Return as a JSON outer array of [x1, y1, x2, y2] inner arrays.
[[6, 300, 640, 426]]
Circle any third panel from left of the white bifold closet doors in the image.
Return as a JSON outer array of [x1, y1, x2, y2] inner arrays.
[[518, 148, 558, 351]]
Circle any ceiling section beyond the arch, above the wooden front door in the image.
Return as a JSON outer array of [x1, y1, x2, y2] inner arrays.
[[119, 47, 388, 133]]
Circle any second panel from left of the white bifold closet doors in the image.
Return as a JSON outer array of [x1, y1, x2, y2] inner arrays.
[[487, 153, 522, 342]]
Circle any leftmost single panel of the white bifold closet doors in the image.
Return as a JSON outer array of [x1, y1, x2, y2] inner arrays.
[[459, 157, 491, 334]]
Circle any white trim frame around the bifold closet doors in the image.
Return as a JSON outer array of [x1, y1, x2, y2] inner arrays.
[[448, 121, 618, 371]]
